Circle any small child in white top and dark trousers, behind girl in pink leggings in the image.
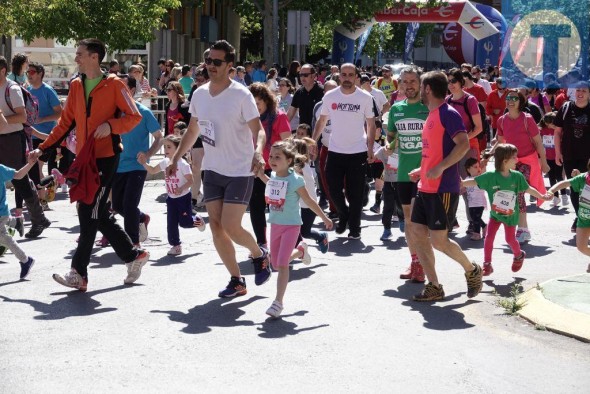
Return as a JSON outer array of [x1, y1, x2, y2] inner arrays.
[[291, 137, 330, 255]]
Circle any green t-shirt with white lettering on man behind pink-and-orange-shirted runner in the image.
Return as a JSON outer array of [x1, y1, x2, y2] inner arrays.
[[387, 100, 428, 182]]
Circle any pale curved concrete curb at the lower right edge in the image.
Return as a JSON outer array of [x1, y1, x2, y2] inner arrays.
[[518, 284, 590, 342]]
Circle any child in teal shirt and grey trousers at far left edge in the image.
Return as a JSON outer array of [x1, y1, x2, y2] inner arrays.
[[0, 157, 37, 279]]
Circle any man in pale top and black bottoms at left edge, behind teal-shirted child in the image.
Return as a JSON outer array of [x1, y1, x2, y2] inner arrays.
[[0, 56, 51, 238]]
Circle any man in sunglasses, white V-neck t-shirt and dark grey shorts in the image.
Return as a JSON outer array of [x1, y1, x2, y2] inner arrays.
[[166, 40, 271, 298]]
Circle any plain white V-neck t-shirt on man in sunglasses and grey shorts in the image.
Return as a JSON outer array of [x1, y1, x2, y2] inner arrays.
[[189, 81, 259, 177]]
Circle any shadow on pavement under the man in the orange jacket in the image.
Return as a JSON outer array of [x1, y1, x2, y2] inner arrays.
[[0, 285, 131, 320]]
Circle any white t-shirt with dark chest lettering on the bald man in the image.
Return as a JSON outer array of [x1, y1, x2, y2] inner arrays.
[[321, 88, 375, 154]]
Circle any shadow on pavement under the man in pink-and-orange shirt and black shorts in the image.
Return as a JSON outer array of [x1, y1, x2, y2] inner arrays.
[[383, 282, 479, 331]]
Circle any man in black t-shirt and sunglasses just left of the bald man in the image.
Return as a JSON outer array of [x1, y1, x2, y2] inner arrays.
[[287, 64, 324, 124]]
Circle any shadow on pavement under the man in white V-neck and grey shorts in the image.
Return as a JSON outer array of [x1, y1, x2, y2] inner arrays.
[[151, 296, 266, 334]]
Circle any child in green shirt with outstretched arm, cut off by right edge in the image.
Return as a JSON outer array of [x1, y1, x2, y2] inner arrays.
[[547, 160, 590, 272]]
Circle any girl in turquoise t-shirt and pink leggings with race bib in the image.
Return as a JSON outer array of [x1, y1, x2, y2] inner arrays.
[[258, 141, 333, 318]]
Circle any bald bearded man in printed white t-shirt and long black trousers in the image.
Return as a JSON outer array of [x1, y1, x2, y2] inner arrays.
[[313, 63, 375, 239]]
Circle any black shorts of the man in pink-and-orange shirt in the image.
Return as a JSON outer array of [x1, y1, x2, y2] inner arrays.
[[412, 192, 459, 231]]
